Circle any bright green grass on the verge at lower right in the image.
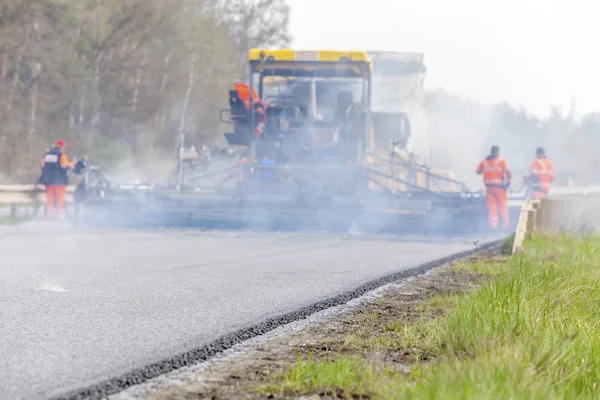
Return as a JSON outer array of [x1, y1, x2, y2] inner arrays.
[[263, 236, 600, 400]]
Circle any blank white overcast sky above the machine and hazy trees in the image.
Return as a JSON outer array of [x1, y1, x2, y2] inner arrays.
[[289, 0, 600, 115]]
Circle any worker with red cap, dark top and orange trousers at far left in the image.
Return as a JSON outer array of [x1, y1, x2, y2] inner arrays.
[[39, 140, 77, 220]]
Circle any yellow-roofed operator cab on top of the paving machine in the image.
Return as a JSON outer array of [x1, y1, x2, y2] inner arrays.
[[225, 49, 372, 166]]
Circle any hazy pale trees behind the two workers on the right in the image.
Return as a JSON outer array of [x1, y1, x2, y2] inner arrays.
[[425, 90, 600, 188]]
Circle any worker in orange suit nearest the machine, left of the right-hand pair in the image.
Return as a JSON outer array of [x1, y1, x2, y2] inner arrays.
[[476, 146, 511, 231]]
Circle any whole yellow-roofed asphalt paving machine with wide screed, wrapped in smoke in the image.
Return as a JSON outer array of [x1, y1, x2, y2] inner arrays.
[[72, 49, 486, 231]]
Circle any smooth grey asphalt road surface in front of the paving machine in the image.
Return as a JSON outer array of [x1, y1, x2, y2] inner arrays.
[[0, 225, 502, 399]]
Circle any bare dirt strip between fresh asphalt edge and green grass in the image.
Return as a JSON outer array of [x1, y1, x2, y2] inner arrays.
[[139, 250, 505, 400]]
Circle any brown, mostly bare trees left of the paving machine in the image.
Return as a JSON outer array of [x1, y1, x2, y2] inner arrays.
[[0, 0, 291, 181]]
